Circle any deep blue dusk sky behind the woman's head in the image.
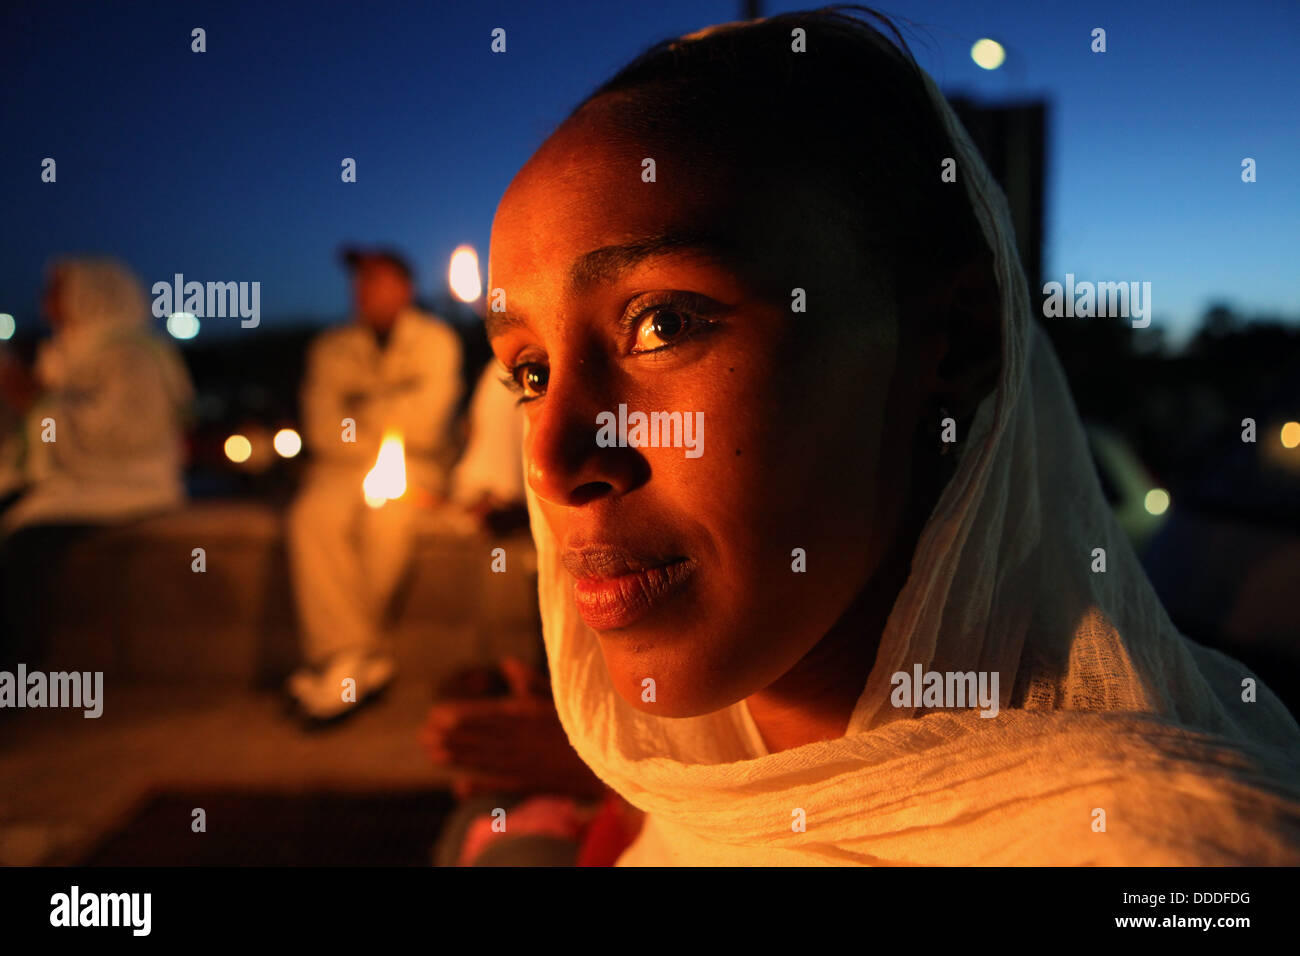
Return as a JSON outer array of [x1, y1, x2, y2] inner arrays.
[[0, 0, 1300, 336]]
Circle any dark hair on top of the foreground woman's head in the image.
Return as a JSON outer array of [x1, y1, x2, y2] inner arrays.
[[573, 7, 987, 300]]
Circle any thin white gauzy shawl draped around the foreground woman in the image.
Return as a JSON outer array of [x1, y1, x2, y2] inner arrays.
[[528, 61, 1300, 865]]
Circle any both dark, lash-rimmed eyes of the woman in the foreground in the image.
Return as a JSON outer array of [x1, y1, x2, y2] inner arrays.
[[499, 291, 722, 405]]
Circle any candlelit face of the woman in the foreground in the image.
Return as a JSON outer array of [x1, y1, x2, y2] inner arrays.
[[488, 100, 922, 717]]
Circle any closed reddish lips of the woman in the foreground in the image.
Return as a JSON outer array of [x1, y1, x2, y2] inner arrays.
[[563, 548, 694, 631]]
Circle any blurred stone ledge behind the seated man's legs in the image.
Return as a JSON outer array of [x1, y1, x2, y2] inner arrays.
[[39, 502, 541, 685]]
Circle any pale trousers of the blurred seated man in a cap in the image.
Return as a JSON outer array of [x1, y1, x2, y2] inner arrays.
[[289, 464, 415, 666]]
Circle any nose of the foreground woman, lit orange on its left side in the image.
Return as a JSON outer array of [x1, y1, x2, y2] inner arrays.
[[524, 369, 650, 507]]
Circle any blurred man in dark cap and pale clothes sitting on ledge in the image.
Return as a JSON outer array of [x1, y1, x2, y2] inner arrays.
[[289, 250, 460, 724]]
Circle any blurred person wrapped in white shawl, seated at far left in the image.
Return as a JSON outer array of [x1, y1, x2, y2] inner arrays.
[[0, 259, 194, 661]]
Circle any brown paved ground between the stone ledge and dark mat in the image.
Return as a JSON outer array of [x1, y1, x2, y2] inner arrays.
[[0, 679, 457, 865]]
